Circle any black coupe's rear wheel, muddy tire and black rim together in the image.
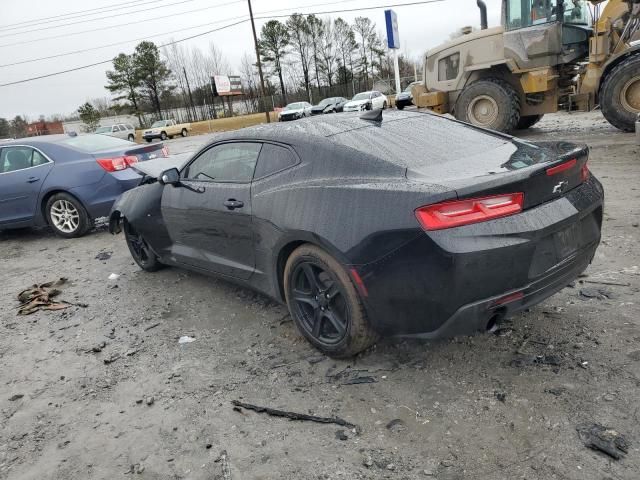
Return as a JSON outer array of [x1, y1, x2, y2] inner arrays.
[[284, 244, 379, 358]]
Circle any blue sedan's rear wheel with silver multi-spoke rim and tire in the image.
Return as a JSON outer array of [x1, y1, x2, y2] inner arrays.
[[45, 193, 93, 238]]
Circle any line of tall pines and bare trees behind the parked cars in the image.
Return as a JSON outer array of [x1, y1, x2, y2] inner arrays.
[[0, 13, 420, 138]]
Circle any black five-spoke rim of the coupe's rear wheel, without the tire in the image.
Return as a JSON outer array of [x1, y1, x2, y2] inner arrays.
[[292, 261, 350, 345]]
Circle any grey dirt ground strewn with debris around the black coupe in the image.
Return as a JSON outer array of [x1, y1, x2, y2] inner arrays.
[[0, 109, 640, 480]]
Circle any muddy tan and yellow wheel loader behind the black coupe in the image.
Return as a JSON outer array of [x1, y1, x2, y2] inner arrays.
[[412, 0, 640, 132]]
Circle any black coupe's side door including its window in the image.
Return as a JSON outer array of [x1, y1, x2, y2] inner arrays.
[[161, 142, 262, 279]]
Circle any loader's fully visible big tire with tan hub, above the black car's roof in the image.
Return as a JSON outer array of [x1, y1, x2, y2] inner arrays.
[[454, 78, 520, 133]]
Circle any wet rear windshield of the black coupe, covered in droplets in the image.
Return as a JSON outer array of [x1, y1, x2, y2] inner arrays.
[[330, 113, 509, 170]]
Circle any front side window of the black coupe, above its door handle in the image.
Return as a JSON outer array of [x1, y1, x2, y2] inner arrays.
[[184, 142, 262, 183]]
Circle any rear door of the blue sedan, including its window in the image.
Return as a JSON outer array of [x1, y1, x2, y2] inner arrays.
[[0, 145, 53, 225]]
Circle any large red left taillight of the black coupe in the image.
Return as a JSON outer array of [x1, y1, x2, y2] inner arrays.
[[415, 193, 524, 230]]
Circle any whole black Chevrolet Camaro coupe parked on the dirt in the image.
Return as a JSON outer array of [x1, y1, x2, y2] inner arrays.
[[110, 111, 604, 357]]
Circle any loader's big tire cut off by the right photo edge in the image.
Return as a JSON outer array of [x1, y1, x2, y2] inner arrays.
[[600, 54, 640, 132]]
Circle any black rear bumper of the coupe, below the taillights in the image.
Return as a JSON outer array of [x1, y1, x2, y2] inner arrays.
[[356, 176, 604, 337]]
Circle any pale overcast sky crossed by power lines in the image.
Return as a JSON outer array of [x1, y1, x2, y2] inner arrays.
[[0, 0, 500, 120]]
